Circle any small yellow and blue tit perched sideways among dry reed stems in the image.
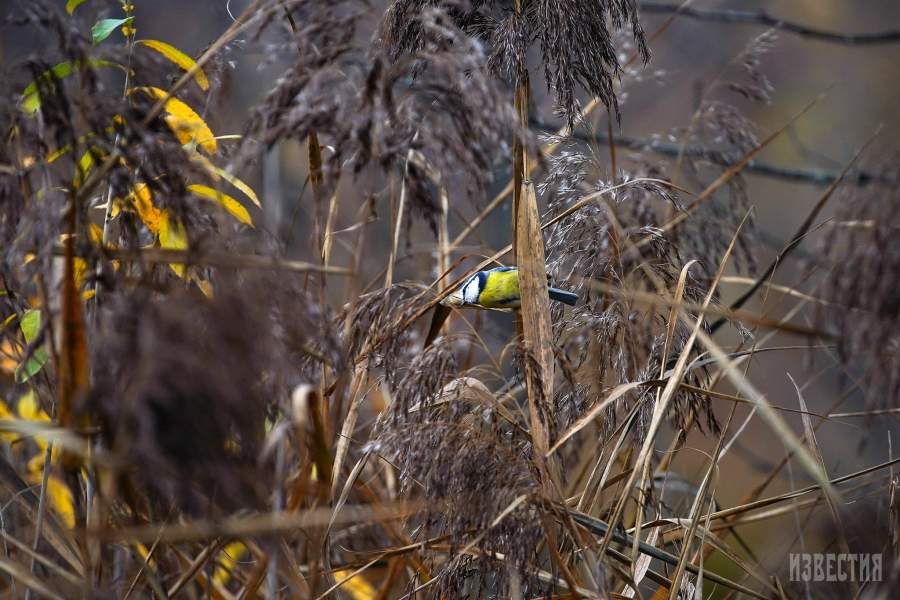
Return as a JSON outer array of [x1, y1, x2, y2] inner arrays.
[[443, 267, 578, 309]]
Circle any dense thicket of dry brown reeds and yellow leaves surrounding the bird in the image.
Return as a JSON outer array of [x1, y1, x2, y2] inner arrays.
[[0, 0, 900, 600]]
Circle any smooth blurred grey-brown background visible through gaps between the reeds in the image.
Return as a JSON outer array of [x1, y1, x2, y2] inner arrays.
[[0, 0, 900, 592]]
